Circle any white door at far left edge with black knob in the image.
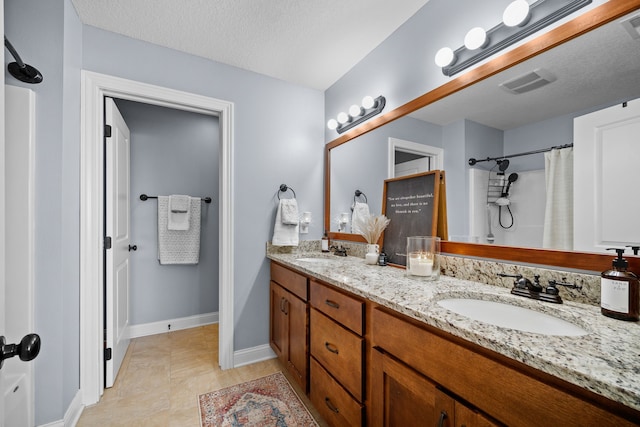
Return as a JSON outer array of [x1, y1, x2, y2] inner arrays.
[[2, 85, 36, 427]]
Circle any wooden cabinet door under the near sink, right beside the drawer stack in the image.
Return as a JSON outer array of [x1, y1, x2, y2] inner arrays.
[[370, 350, 455, 427]]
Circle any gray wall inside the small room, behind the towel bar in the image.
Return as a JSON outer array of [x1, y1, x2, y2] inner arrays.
[[116, 100, 220, 325]]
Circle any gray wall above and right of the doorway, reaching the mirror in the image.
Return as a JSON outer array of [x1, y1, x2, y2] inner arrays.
[[82, 0, 323, 358]]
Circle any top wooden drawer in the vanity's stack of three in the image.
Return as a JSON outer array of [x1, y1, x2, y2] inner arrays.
[[309, 280, 364, 335]]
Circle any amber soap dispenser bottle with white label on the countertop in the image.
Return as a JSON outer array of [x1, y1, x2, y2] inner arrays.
[[600, 248, 640, 321]]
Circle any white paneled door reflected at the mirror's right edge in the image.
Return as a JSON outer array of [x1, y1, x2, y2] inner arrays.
[[573, 99, 640, 255]]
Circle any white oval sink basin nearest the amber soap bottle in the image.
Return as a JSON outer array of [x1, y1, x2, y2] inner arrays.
[[438, 298, 588, 336]]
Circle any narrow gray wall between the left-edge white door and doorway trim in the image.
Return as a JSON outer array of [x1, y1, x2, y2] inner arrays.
[[5, 0, 82, 424]]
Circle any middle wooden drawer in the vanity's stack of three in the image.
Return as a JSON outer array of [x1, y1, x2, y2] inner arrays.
[[310, 308, 364, 402]]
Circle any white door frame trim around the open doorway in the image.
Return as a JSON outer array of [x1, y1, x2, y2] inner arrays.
[[80, 70, 234, 405]]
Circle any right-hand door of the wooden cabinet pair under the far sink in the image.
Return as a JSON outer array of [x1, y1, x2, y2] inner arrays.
[[284, 291, 309, 392]]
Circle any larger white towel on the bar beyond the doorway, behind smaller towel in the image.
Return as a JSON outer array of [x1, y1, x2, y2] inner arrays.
[[158, 196, 201, 265]]
